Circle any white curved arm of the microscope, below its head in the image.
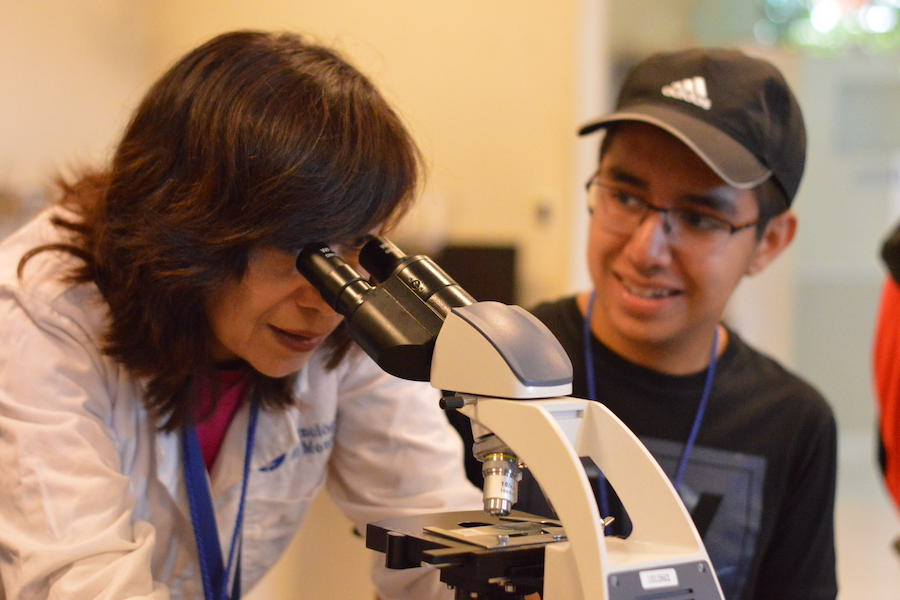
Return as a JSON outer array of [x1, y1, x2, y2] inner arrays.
[[461, 396, 721, 600]]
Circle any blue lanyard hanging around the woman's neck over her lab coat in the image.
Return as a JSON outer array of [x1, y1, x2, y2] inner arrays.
[[182, 401, 259, 600]]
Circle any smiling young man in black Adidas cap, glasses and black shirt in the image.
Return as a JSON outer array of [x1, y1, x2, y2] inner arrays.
[[516, 49, 837, 600]]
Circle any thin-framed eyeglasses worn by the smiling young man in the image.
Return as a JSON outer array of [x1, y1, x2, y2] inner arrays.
[[586, 175, 759, 252]]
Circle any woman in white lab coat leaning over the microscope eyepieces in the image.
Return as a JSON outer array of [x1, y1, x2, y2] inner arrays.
[[0, 31, 480, 599]]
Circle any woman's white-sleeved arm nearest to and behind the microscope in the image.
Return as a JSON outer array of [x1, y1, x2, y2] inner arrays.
[[327, 351, 481, 600]]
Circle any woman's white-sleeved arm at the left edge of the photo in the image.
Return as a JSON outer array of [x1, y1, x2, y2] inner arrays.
[[0, 289, 169, 600]]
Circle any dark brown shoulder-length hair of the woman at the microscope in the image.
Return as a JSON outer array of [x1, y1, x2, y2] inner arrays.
[[19, 31, 421, 430]]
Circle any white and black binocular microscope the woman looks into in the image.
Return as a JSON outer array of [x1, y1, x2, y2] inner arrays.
[[297, 237, 723, 600]]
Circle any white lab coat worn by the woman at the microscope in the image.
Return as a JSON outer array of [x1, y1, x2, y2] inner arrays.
[[0, 212, 480, 600]]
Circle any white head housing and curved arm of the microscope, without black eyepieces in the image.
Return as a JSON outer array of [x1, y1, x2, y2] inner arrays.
[[431, 302, 722, 600]]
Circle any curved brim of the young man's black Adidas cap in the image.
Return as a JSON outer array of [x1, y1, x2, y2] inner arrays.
[[578, 104, 772, 189]]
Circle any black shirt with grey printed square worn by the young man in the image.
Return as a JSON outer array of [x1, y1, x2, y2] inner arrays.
[[515, 297, 837, 600]]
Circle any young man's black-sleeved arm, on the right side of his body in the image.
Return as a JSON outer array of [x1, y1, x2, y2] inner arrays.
[[752, 412, 837, 600]]
